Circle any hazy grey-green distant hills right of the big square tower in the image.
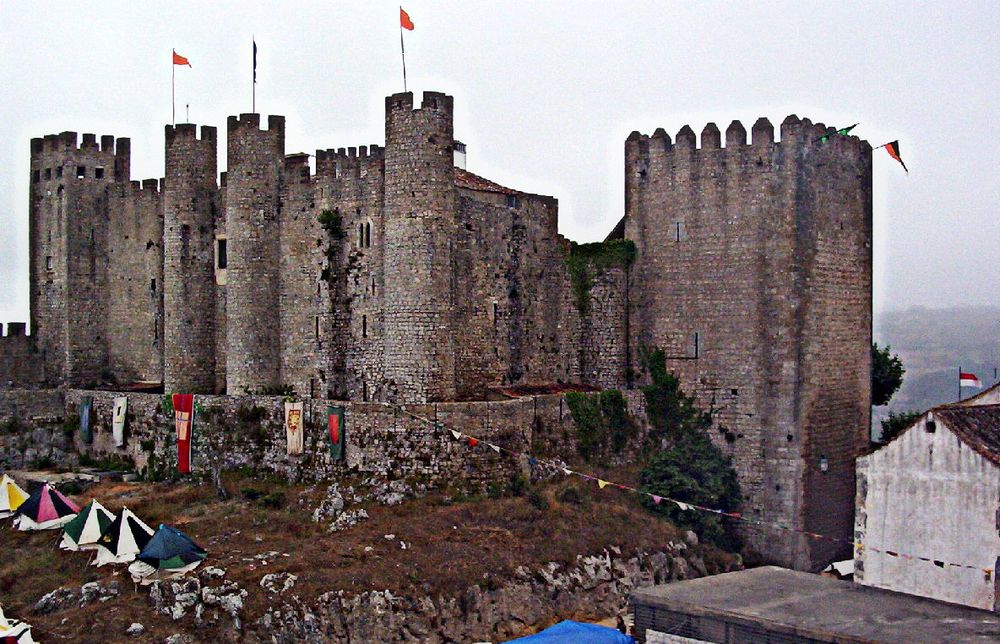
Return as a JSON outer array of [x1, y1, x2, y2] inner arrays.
[[873, 306, 1000, 422]]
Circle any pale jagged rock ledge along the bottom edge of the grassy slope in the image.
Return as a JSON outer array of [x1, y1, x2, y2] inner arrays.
[[249, 542, 732, 643]]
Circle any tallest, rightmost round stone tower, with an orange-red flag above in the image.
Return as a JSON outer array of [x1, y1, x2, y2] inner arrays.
[[383, 92, 458, 402]]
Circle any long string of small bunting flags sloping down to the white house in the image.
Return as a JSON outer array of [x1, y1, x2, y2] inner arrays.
[[393, 405, 993, 581]]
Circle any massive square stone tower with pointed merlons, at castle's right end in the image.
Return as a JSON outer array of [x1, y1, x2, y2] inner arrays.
[[624, 117, 871, 568]]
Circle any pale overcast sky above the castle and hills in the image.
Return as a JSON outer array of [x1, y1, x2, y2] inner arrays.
[[0, 0, 1000, 328]]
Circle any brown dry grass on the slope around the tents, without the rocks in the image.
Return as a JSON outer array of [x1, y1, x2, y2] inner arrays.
[[0, 471, 731, 641]]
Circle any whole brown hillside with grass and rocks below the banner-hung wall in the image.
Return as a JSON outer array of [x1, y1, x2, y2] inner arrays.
[[0, 472, 738, 642]]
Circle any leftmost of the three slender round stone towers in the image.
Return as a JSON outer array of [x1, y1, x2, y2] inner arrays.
[[163, 123, 218, 394]]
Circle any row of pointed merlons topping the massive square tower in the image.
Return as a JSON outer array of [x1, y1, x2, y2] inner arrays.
[[625, 114, 870, 166]]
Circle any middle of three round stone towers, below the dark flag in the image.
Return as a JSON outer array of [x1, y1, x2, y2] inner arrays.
[[226, 114, 285, 395]]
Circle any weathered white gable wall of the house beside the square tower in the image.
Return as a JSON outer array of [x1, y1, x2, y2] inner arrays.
[[854, 412, 1000, 610]]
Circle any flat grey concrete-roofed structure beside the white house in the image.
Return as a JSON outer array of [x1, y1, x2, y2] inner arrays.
[[632, 566, 1000, 644]]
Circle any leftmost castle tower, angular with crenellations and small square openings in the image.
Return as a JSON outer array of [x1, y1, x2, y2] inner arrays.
[[28, 132, 130, 385]]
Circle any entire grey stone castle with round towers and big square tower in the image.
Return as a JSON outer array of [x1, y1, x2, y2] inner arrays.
[[0, 92, 872, 566]]
